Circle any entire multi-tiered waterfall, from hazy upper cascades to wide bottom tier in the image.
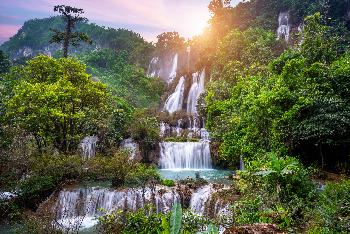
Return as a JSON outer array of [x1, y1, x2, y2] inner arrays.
[[51, 49, 232, 230]]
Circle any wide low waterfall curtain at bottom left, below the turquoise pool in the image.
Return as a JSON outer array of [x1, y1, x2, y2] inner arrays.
[[55, 187, 179, 229]]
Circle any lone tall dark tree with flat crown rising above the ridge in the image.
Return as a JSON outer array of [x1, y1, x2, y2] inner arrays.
[[51, 5, 92, 58]]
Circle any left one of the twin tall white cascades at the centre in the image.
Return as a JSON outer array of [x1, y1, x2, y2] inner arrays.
[[164, 77, 185, 113]]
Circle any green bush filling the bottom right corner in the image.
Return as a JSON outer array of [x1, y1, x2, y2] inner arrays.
[[308, 180, 350, 233]]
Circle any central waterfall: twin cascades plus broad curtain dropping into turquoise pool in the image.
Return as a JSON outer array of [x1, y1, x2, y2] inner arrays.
[[159, 65, 212, 170]]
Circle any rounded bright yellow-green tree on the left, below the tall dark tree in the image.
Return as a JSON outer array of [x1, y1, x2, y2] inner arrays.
[[5, 55, 109, 153]]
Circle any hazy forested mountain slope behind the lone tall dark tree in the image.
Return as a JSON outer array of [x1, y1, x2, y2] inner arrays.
[[0, 16, 162, 106]]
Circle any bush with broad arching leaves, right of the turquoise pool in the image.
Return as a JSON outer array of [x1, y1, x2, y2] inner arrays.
[[239, 153, 316, 203]]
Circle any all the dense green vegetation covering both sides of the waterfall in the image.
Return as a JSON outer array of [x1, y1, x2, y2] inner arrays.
[[0, 0, 350, 233]]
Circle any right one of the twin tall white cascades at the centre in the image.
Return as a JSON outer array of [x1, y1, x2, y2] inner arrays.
[[187, 70, 205, 114]]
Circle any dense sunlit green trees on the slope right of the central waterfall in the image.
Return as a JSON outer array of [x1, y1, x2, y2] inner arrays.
[[206, 14, 350, 171]]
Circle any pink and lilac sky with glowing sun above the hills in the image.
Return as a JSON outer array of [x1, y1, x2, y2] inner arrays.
[[0, 0, 238, 44]]
